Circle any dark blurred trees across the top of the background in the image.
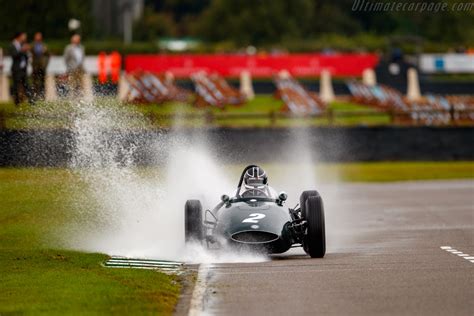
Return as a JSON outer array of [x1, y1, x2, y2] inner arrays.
[[0, 0, 474, 53]]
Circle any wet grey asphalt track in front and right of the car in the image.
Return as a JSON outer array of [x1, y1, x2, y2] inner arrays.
[[194, 181, 474, 315]]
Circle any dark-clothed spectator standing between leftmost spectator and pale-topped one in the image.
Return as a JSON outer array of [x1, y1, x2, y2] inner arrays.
[[31, 32, 49, 100]]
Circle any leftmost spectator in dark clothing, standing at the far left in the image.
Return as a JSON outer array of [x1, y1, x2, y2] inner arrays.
[[10, 32, 31, 105]]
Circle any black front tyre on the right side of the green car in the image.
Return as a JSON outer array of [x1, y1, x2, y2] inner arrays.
[[303, 194, 326, 258]]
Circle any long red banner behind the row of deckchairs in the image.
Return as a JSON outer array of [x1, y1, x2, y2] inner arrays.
[[125, 54, 379, 77]]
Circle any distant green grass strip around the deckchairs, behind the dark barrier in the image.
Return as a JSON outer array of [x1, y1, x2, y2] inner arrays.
[[0, 95, 390, 129]]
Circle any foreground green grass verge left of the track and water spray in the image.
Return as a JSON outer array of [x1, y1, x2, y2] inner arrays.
[[0, 168, 181, 315]]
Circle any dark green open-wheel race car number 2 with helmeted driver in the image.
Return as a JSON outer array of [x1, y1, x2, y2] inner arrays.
[[185, 165, 326, 258]]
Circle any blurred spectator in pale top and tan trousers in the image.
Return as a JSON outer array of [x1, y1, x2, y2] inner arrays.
[[64, 34, 85, 95]]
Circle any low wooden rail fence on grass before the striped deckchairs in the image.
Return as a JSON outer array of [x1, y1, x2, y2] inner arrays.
[[0, 109, 474, 130]]
